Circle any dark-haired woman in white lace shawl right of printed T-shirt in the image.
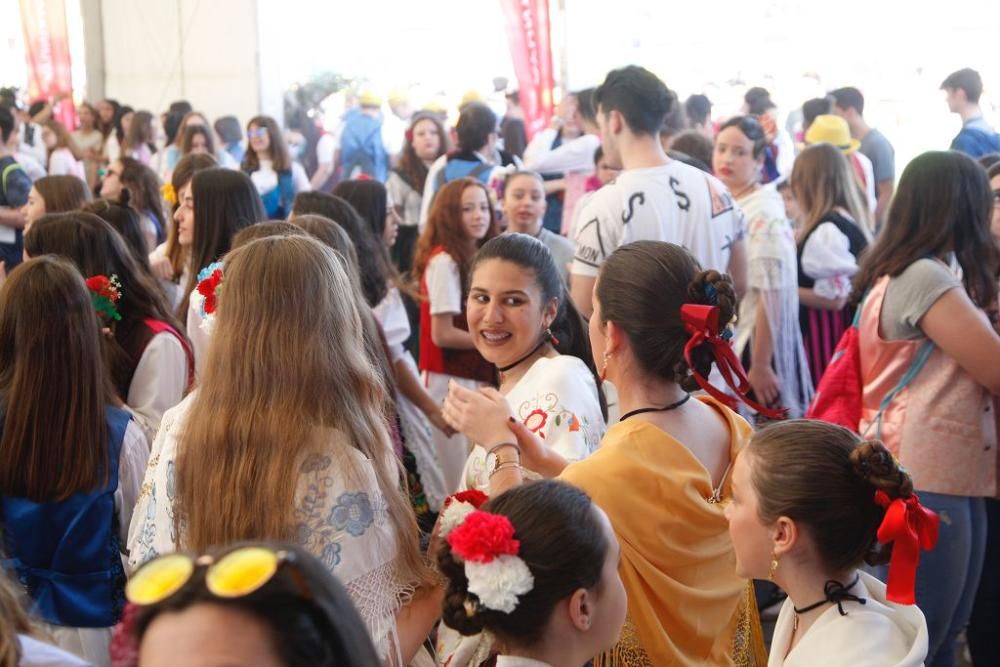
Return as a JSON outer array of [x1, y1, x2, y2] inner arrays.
[[712, 116, 812, 417]]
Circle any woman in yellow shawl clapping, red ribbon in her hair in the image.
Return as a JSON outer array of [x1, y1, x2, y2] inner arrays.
[[444, 241, 766, 667]]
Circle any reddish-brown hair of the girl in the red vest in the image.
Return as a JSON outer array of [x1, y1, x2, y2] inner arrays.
[[413, 178, 498, 294]]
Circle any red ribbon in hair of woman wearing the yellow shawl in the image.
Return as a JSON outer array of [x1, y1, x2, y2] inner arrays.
[[681, 303, 785, 419]]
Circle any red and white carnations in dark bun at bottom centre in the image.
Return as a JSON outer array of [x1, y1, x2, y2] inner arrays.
[[447, 510, 535, 614]]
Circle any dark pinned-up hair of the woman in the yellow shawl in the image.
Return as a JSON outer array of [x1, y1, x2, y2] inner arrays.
[[597, 241, 737, 391]]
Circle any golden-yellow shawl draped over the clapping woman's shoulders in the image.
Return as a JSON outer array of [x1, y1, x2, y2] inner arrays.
[[561, 397, 766, 667]]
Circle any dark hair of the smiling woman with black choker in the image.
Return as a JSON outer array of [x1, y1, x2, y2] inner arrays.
[[466, 233, 608, 419]]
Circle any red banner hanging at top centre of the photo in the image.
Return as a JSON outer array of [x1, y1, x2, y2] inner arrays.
[[500, 0, 553, 140]]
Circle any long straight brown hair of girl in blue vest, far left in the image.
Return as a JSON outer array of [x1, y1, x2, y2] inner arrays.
[[0, 256, 114, 502]]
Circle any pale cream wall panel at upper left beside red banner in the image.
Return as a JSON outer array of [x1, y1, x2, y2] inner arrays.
[[97, 0, 261, 122]]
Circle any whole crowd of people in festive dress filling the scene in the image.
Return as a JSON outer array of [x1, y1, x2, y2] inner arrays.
[[0, 66, 1000, 667]]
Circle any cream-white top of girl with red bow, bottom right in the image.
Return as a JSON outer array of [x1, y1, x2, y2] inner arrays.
[[767, 572, 927, 667]]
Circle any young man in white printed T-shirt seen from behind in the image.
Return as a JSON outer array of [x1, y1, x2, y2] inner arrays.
[[572, 65, 747, 317]]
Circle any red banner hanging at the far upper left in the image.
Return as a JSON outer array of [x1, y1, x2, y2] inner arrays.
[[21, 0, 76, 130]]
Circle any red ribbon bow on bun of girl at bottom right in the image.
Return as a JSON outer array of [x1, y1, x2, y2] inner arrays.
[[875, 491, 939, 604]]
